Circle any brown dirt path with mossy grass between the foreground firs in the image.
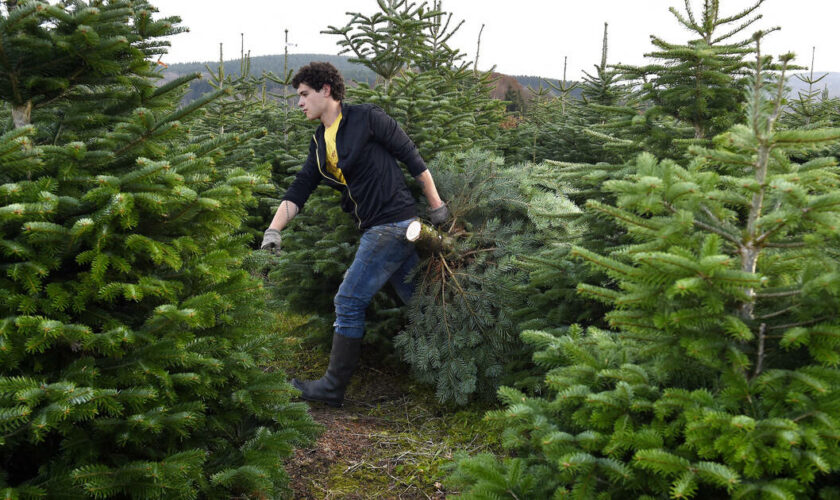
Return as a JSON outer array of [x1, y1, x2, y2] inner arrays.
[[286, 359, 497, 500]]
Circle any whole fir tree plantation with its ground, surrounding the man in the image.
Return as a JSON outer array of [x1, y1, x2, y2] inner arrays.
[[0, 0, 840, 500]]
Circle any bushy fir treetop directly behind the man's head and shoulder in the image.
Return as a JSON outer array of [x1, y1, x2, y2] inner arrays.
[[324, 0, 504, 155]]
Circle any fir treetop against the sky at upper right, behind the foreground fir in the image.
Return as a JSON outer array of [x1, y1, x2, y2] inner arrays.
[[596, 0, 764, 158]]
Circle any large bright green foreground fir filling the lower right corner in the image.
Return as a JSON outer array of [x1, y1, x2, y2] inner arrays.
[[457, 33, 840, 499]]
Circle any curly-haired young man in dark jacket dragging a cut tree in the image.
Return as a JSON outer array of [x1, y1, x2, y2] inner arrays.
[[261, 62, 449, 406]]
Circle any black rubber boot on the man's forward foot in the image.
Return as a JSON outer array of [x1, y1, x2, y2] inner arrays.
[[292, 333, 362, 408]]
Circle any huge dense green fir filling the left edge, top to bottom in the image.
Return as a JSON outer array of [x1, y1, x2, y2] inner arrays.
[[0, 0, 315, 498]]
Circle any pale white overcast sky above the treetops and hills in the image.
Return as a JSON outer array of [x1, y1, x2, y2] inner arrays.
[[154, 0, 840, 79]]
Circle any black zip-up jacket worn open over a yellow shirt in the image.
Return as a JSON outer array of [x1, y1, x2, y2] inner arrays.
[[283, 103, 426, 229]]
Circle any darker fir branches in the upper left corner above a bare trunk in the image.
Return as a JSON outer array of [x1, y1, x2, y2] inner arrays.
[[0, 0, 183, 135]]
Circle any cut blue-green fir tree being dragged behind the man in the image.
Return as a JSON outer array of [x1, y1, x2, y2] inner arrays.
[[395, 150, 578, 404]]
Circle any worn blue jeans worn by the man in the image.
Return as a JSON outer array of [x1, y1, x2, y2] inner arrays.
[[333, 219, 419, 338]]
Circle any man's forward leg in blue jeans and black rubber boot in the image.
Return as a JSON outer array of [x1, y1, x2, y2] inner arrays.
[[292, 221, 416, 406]]
